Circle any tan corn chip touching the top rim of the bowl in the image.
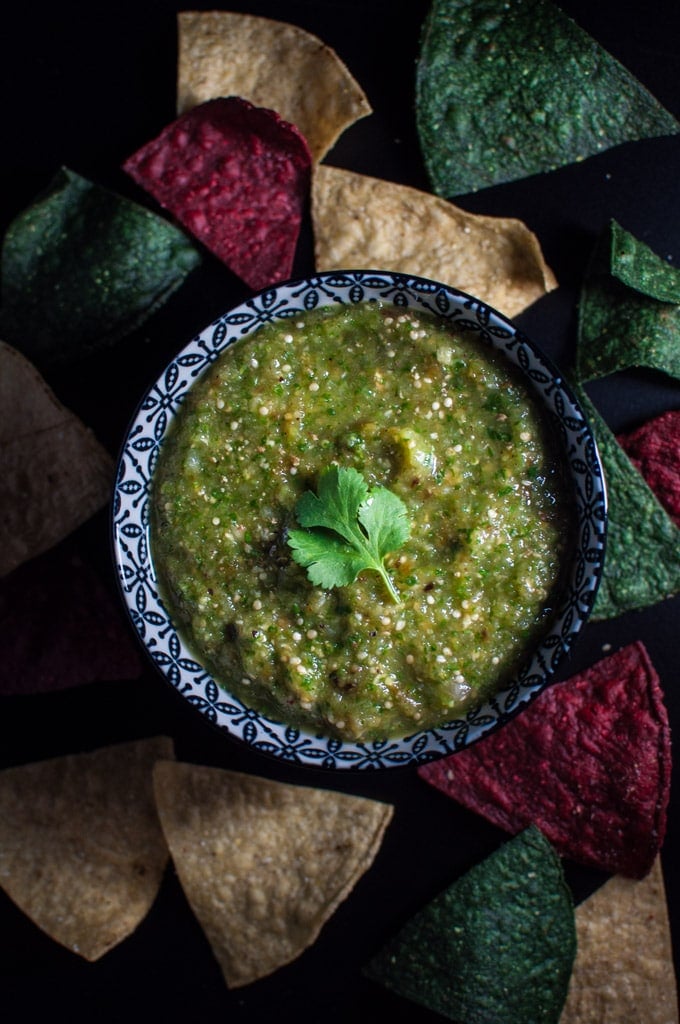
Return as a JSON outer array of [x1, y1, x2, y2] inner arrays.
[[311, 165, 557, 316]]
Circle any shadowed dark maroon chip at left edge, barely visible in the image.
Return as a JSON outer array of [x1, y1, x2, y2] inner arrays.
[[0, 542, 142, 696]]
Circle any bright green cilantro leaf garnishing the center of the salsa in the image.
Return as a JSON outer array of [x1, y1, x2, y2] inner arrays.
[[288, 466, 410, 603]]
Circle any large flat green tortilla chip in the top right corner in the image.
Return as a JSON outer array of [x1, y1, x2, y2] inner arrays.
[[416, 0, 680, 198]]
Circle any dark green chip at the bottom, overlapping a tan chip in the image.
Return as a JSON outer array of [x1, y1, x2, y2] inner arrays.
[[366, 826, 577, 1024]]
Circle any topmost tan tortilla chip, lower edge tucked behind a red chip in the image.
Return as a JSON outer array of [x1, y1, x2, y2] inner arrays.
[[177, 10, 371, 161]]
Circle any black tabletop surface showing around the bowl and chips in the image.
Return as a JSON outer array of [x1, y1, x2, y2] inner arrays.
[[0, 0, 680, 1024]]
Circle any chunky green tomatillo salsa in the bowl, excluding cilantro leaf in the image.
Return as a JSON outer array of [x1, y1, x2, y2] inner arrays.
[[151, 302, 570, 740]]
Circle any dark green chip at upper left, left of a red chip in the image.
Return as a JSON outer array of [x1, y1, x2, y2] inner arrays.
[[0, 168, 201, 367]]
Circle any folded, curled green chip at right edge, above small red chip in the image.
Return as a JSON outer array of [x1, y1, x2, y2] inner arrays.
[[577, 220, 680, 381]]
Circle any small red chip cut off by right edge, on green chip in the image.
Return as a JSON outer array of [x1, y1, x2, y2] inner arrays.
[[617, 409, 680, 526]]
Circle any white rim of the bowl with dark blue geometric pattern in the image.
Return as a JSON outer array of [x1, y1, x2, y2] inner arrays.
[[113, 270, 606, 769]]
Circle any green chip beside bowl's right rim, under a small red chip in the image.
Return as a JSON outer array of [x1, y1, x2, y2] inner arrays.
[[575, 387, 680, 621]]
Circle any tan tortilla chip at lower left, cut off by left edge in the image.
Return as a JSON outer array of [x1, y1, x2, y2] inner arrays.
[[0, 736, 172, 961]]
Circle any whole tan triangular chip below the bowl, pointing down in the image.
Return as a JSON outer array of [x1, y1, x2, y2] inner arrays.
[[154, 762, 392, 988]]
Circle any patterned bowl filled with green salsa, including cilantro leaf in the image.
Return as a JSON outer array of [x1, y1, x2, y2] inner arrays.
[[113, 270, 606, 769]]
